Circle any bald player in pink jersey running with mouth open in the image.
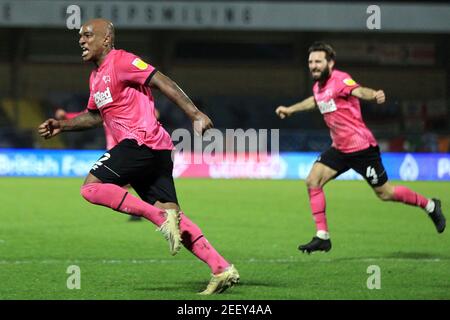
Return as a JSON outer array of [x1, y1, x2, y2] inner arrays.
[[38, 19, 239, 295]]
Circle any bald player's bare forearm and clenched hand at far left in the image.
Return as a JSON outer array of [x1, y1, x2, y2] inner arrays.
[[38, 112, 103, 139]]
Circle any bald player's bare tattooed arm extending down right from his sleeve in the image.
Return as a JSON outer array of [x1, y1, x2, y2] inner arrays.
[[150, 71, 213, 134]]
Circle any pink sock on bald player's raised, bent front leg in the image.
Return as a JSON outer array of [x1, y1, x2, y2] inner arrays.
[[81, 183, 166, 227]]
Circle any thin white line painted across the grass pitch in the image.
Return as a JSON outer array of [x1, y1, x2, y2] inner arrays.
[[0, 258, 442, 265]]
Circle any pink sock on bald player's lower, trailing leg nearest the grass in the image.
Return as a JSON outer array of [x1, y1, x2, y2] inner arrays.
[[180, 212, 230, 274]]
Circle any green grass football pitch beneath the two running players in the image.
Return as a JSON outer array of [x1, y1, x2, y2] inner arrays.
[[0, 178, 450, 300]]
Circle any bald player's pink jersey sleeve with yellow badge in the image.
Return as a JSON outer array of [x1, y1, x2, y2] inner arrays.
[[116, 54, 157, 85]]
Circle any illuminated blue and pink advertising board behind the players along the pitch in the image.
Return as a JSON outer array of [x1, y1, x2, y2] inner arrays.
[[0, 149, 450, 181]]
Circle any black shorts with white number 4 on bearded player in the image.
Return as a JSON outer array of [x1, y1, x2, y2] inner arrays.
[[317, 146, 388, 187]]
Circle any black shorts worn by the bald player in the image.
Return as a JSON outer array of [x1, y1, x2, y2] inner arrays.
[[90, 139, 178, 204]]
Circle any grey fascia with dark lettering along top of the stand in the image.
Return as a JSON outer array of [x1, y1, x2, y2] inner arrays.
[[0, 0, 450, 32]]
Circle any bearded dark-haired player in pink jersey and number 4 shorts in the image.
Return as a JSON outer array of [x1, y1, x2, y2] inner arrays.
[[275, 42, 446, 253]]
